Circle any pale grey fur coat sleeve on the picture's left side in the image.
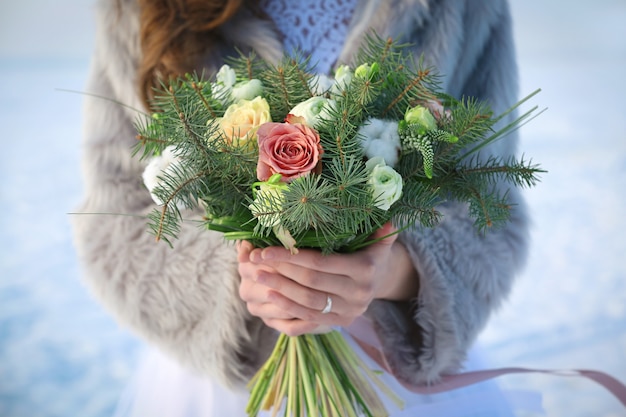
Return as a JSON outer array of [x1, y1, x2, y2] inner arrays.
[[73, 1, 274, 385]]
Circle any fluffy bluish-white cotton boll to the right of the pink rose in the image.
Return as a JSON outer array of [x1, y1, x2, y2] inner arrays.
[[358, 119, 402, 167]]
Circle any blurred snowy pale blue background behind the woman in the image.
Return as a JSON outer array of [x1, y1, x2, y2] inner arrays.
[[0, 0, 626, 417]]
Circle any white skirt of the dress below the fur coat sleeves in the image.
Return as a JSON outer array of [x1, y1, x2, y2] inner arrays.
[[113, 331, 543, 417]]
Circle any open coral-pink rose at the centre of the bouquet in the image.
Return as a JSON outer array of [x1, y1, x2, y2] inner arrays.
[[256, 119, 323, 181]]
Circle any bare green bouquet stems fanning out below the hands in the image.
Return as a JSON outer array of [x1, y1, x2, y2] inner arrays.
[[246, 331, 402, 417]]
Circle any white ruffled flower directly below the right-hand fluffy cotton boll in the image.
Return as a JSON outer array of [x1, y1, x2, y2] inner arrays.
[[365, 157, 402, 210]]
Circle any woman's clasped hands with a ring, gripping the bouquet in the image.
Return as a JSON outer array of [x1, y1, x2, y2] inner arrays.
[[238, 224, 419, 336]]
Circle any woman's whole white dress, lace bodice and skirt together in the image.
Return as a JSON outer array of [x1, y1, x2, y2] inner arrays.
[[114, 0, 542, 417]]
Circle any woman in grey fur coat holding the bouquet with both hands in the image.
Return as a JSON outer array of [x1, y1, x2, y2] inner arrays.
[[74, 0, 528, 412]]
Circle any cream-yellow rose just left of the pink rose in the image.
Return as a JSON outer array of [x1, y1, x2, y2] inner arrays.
[[219, 97, 271, 145]]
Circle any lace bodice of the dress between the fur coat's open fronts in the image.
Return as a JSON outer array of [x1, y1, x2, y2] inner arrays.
[[259, 0, 357, 74]]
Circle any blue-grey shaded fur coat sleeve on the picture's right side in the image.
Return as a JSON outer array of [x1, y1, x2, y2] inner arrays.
[[368, 1, 528, 383]]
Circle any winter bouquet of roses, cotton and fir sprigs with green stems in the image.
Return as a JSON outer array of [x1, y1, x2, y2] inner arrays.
[[137, 36, 542, 416]]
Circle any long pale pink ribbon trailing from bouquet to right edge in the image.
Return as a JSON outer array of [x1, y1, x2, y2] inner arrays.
[[346, 317, 626, 407]]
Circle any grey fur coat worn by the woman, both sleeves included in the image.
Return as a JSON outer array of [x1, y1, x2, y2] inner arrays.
[[73, 0, 528, 387]]
